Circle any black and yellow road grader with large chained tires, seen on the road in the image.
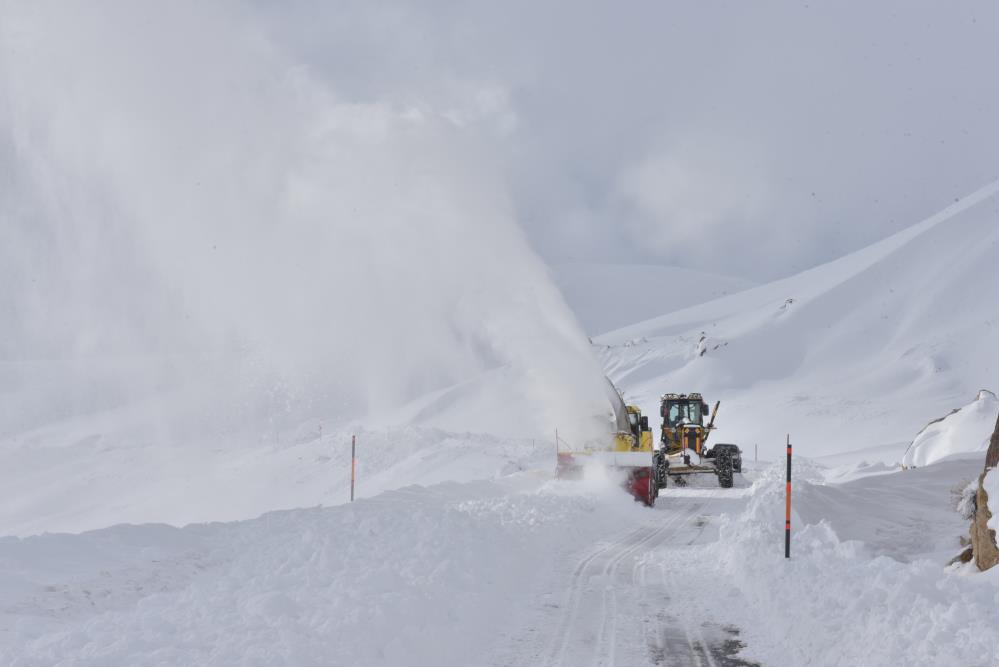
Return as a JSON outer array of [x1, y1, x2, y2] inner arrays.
[[654, 393, 735, 489]]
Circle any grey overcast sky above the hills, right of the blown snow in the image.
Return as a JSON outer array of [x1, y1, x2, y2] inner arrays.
[[263, 1, 999, 280]]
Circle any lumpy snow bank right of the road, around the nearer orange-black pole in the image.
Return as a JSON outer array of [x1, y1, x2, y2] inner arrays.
[[705, 464, 999, 665]]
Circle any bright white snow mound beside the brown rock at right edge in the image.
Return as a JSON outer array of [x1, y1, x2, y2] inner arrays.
[[902, 390, 999, 468]]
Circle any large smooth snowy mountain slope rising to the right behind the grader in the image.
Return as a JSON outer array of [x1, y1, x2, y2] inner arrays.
[[595, 183, 999, 462]]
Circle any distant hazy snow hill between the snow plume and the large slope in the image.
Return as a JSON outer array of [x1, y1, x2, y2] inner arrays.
[[552, 263, 754, 336]]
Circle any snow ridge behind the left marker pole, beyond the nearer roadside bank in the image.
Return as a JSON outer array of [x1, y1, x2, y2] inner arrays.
[[0, 422, 555, 536]]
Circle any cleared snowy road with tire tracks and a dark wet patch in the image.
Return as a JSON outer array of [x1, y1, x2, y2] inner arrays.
[[491, 482, 752, 667]]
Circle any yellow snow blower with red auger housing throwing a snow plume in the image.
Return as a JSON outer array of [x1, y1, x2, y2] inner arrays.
[[555, 394, 659, 507]]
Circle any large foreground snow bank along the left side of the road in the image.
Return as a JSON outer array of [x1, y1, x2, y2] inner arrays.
[[0, 477, 647, 666]]
